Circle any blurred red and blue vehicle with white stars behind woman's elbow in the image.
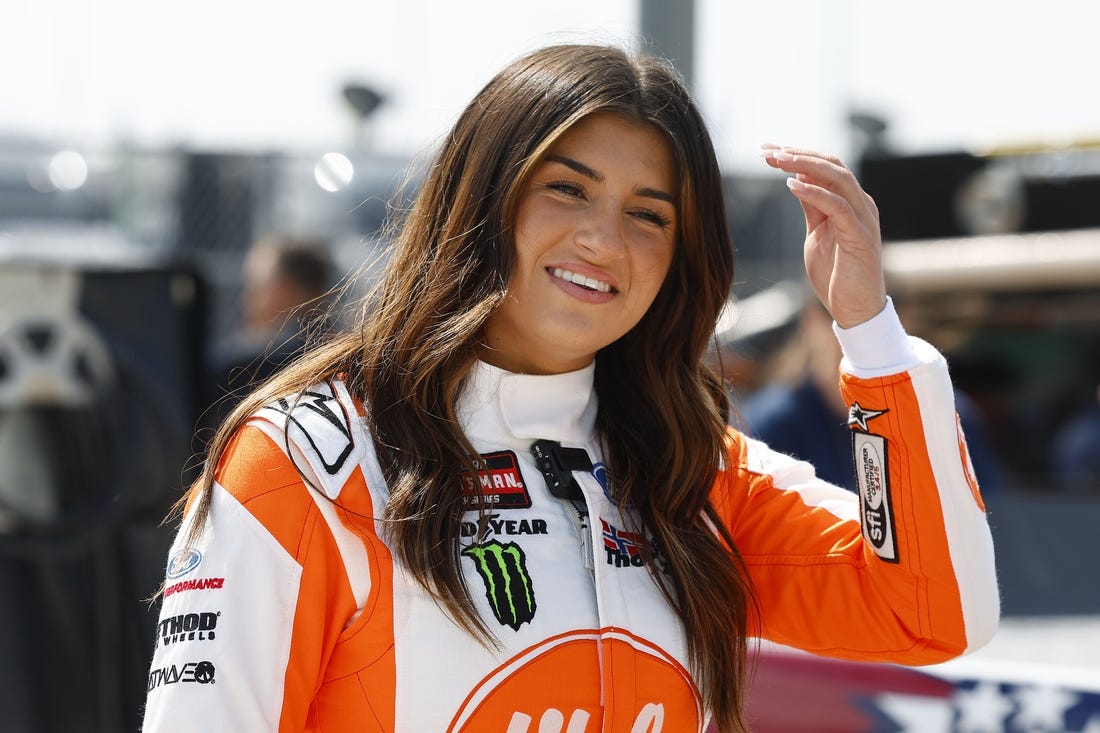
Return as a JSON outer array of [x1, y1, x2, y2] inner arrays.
[[748, 645, 1100, 733]]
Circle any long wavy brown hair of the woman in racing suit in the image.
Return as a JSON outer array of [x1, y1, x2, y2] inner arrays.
[[193, 45, 752, 731]]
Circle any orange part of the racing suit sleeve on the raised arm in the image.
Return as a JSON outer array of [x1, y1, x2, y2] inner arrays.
[[714, 367, 967, 664]]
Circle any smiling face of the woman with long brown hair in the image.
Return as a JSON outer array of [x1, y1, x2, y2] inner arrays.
[[481, 112, 680, 374]]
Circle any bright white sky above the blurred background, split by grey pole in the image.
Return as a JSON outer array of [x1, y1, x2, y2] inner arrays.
[[0, 0, 1100, 171]]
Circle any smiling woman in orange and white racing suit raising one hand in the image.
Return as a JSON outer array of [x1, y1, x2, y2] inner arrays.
[[145, 46, 998, 733]]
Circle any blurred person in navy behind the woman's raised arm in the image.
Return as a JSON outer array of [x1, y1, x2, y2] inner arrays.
[[734, 296, 1002, 493]]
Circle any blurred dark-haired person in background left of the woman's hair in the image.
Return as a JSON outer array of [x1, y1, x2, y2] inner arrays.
[[200, 233, 337, 429]]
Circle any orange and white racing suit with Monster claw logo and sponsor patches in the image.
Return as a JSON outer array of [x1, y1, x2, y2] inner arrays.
[[137, 299, 999, 733]]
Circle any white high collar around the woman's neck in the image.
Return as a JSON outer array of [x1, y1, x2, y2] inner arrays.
[[458, 361, 596, 450]]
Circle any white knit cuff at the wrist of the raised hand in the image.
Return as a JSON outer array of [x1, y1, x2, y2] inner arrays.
[[833, 296, 922, 379]]
